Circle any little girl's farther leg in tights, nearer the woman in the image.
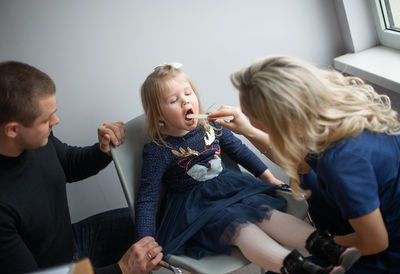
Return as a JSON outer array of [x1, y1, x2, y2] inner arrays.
[[258, 210, 315, 249]]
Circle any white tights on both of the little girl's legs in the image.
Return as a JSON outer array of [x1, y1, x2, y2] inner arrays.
[[234, 210, 315, 272]]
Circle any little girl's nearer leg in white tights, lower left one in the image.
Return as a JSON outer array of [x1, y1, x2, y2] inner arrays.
[[234, 224, 290, 272]]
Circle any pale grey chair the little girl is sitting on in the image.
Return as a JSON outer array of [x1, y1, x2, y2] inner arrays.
[[111, 115, 308, 274]]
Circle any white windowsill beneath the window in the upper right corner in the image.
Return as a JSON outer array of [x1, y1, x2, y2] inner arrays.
[[333, 46, 400, 93]]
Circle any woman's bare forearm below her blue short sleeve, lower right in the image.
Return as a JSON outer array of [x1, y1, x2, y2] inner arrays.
[[335, 208, 389, 256]]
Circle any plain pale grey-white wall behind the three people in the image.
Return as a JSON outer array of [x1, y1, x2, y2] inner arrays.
[[0, 0, 344, 221]]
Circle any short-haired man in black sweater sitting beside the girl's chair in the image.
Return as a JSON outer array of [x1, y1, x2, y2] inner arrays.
[[0, 61, 163, 273]]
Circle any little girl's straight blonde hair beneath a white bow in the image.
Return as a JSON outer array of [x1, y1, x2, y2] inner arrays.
[[141, 64, 209, 145]]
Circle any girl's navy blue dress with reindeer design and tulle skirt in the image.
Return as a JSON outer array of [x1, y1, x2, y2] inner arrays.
[[135, 125, 286, 258]]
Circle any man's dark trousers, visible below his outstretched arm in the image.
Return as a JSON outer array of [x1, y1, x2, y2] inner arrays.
[[72, 208, 135, 267]]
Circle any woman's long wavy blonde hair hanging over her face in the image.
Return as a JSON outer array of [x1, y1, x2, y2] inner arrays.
[[231, 56, 400, 197]]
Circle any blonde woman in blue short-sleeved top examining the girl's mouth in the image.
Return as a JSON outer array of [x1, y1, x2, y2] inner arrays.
[[210, 56, 400, 273]]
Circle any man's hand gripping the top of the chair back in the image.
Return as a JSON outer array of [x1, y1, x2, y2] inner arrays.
[[97, 122, 125, 156]]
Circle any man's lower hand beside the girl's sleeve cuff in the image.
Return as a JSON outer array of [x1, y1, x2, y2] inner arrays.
[[118, 237, 163, 274]]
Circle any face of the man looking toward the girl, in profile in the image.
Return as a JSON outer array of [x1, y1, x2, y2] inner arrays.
[[16, 94, 60, 150]]
